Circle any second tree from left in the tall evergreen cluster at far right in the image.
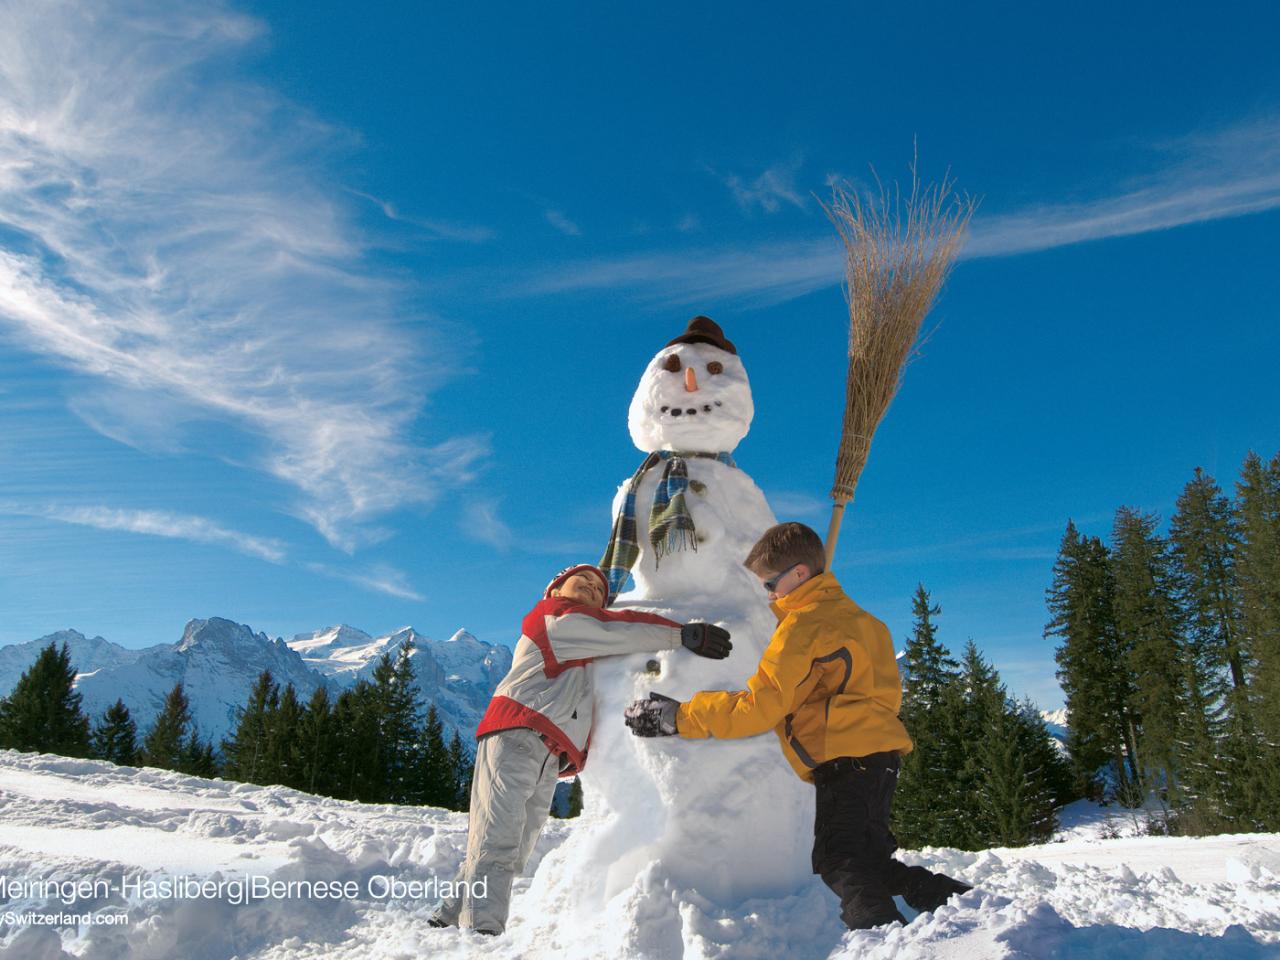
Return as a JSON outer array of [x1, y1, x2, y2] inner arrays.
[[1111, 507, 1188, 803]]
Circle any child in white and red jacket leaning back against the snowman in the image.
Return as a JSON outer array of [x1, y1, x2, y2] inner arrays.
[[431, 563, 732, 934]]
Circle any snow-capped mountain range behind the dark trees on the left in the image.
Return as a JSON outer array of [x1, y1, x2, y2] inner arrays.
[[0, 617, 511, 745]]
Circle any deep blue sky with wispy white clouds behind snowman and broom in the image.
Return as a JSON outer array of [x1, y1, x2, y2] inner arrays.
[[0, 3, 1280, 707]]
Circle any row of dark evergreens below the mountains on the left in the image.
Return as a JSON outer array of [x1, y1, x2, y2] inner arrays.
[[0, 640, 474, 810]]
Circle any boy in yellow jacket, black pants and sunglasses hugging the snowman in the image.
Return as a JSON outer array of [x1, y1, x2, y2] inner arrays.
[[626, 524, 970, 929]]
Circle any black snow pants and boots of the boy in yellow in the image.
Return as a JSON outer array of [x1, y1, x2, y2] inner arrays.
[[813, 751, 966, 929]]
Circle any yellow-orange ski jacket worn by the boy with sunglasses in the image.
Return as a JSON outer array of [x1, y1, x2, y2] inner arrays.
[[676, 573, 911, 781]]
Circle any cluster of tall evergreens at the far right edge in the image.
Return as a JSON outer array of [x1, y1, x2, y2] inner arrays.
[[1044, 452, 1280, 835]]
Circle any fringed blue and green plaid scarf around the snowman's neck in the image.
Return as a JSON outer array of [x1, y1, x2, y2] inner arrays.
[[600, 451, 736, 603]]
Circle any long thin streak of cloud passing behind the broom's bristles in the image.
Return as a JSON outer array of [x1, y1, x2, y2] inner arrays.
[[522, 116, 1280, 306]]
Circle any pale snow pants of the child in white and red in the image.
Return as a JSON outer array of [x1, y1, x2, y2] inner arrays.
[[436, 727, 559, 933]]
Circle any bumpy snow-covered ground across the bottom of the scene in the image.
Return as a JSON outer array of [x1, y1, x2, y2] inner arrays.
[[0, 751, 1280, 960]]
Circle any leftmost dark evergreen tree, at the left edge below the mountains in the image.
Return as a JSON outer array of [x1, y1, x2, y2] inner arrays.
[[0, 641, 90, 756]]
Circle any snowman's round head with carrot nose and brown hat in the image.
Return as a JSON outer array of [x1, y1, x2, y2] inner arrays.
[[627, 316, 755, 453]]
